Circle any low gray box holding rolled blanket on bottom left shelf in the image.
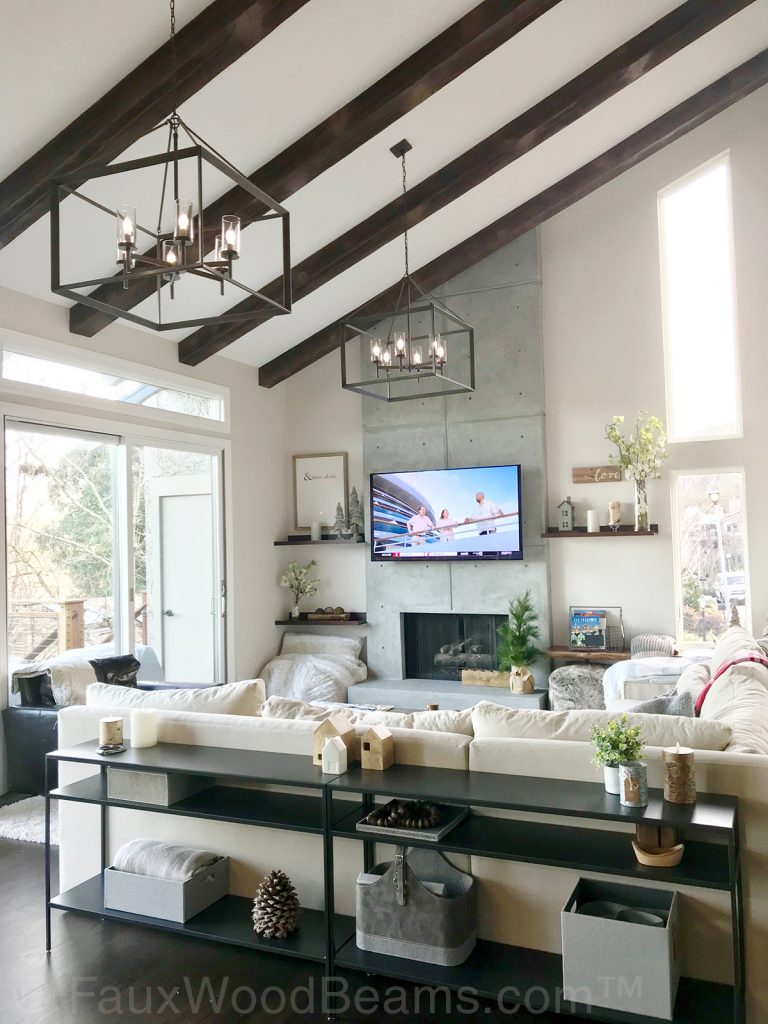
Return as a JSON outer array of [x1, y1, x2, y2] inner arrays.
[[104, 857, 229, 924]]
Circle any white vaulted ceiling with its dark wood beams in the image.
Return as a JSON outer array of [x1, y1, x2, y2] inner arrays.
[[0, 0, 768, 386]]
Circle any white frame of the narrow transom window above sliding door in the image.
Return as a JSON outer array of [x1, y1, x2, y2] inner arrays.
[[0, 328, 230, 434]]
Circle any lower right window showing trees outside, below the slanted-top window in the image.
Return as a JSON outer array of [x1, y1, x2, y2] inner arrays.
[[674, 470, 750, 644]]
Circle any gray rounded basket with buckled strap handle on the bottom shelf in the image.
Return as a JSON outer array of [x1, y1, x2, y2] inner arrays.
[[356, 847, 477, 967]]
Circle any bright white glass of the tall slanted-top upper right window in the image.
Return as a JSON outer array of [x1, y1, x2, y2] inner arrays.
[[658, 154, 741, 441]]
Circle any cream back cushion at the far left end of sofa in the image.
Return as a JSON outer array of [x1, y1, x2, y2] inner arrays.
[[85, 679, 265, 718]]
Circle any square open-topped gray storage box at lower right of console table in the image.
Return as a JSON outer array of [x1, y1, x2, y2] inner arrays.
[[561, 879, 680, 1020]]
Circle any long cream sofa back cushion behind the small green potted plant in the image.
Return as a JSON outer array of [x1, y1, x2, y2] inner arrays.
[[472, 701, 733, 751]]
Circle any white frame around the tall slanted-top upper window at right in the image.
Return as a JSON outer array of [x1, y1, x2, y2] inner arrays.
[[656, 150, 743, 444]]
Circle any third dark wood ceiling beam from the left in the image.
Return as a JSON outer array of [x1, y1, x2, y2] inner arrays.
[[179, 0, 754, 366]]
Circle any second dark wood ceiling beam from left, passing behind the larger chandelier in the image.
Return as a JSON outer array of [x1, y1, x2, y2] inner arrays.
[[70, 0, 560, 338]]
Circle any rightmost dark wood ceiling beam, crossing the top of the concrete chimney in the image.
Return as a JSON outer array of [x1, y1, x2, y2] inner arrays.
[[259, 50, 768, 387]]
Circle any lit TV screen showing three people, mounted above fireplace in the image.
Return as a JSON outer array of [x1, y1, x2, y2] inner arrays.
[[371, 466, 522, 561]]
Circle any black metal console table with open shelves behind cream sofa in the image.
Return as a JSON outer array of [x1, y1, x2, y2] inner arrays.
[[45, 742, 745, 1024]]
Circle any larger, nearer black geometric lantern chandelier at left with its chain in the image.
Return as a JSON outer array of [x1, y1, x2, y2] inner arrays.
[[50, 0, 292, 331]]
